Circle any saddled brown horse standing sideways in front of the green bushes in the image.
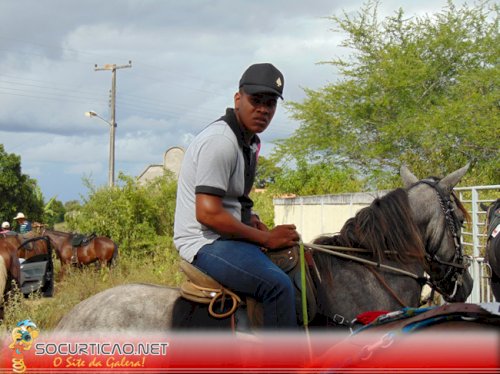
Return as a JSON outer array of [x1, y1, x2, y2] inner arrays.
[[41, 229, 118, 273]]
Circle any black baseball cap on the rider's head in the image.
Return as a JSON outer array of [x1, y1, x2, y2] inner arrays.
[[240, 63, 285, 99]]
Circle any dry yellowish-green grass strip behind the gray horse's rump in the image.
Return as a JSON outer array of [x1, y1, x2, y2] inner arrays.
[[0, 249, 183, 334]]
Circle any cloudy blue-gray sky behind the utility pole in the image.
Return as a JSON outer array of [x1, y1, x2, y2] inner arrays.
[[0, 0, 459, 202]]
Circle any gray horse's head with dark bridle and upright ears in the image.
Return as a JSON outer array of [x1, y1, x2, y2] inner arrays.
[[401, 164, 473, 302]]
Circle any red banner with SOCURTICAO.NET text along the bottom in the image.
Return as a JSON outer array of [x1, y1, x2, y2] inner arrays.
[[0, 330, 500, 373]]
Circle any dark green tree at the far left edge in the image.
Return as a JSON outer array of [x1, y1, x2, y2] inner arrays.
[[0, 144, 44, 223]]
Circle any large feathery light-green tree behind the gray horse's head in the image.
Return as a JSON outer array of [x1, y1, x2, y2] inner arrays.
[[273, 1, 500, 189]]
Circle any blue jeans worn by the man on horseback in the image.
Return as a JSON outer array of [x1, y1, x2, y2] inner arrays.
[[193, 239, 297, 328]]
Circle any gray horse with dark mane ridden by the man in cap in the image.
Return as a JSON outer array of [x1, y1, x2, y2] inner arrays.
[[55, 165, 472, 333]]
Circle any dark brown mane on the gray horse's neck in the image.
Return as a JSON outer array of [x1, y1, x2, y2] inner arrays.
[[314, 188, 425, 263]]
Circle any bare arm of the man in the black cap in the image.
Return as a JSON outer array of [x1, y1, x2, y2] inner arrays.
[[196, 193, 299, 250]]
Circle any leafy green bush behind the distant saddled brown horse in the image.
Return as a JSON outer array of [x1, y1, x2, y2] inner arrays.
[[65, 173, 177, 254]]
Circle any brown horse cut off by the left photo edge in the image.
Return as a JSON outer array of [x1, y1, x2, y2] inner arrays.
[[0, 237, 21, 318]]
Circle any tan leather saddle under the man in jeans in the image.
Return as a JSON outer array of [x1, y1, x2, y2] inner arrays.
[[180, 246, 317, 328]]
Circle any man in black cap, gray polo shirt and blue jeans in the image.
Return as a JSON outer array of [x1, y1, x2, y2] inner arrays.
[[174, 63, 299, 328]]
